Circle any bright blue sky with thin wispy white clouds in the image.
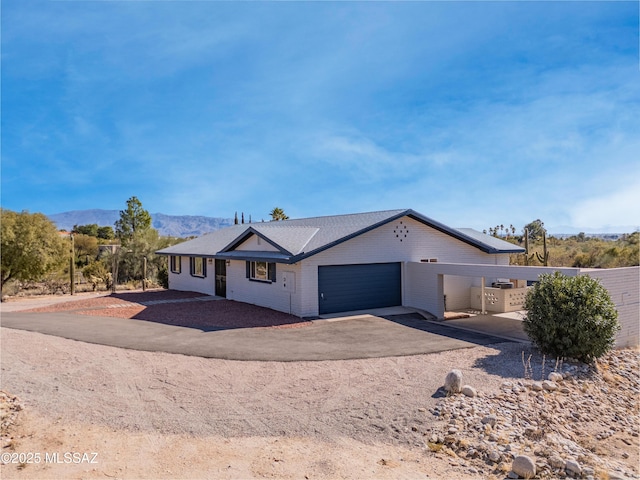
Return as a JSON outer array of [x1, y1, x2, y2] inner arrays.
[[2, 0, 640, 230]]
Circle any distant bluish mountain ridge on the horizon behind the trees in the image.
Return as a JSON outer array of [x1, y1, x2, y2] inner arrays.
[[47, 209, 233, 238]]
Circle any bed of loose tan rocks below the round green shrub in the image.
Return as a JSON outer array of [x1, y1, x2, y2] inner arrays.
[[425, 350, 640, 479]]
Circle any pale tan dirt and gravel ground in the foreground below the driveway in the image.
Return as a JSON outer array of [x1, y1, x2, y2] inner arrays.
[[0, 294, 635, 479]]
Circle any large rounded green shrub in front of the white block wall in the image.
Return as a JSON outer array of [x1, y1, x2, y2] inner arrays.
[[524, 272, 620, 362]]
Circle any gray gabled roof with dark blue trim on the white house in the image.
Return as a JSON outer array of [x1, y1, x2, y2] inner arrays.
[[157, 209, 524, 263]]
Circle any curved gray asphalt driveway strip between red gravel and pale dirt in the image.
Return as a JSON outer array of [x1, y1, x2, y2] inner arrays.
[[1, 312, 505, 361]]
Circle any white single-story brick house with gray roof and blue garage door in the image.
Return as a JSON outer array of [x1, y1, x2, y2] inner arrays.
[[157, 210, 524, 317]]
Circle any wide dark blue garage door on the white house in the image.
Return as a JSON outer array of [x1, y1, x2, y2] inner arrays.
[[318, 263, 402, 314]]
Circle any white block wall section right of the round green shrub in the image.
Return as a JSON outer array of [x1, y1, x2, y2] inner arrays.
[[580, 267, 640, 348]]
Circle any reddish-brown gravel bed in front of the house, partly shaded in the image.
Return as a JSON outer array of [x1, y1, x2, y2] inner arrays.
[[25, 290, 310, 330]]
